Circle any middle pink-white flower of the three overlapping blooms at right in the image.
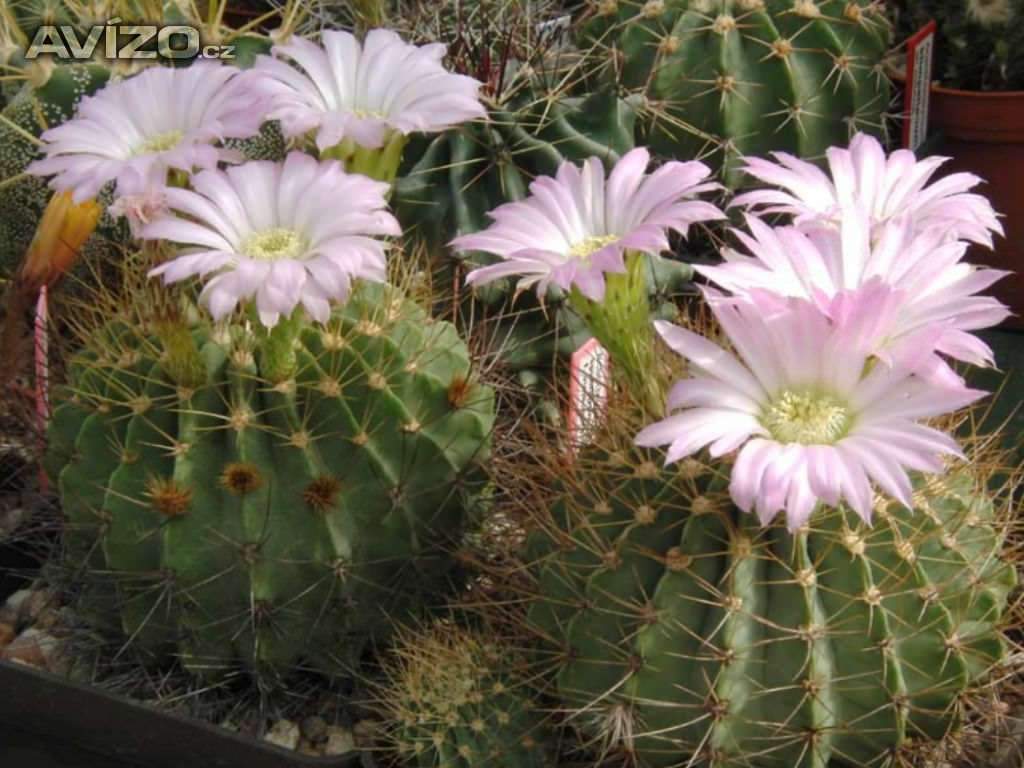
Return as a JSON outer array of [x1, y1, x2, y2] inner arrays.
[[696, 209, 1010, 382]]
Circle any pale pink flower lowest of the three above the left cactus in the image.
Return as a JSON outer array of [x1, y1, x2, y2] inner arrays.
[[142, 153, 401, 327]]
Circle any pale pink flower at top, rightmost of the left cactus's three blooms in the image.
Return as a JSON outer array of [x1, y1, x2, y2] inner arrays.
[[255, 30, 485, 150]]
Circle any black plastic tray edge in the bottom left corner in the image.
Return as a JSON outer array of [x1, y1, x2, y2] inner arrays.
[[0, 542, 360, 768]]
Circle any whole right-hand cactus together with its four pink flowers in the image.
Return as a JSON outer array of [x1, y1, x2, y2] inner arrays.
[[456, 105, 1017, 766]]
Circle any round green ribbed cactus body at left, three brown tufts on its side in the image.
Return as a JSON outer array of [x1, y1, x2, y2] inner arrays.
[[46, 286, 494, 674]]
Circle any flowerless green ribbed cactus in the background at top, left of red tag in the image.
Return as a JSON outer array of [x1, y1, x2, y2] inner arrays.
[[583, 0, 890, 185]]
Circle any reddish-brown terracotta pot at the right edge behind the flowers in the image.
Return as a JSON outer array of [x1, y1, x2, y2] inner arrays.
[[929, 86, 1024, 328]]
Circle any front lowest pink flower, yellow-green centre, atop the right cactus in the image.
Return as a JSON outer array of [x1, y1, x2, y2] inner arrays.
[[636, 287, 984, 530]]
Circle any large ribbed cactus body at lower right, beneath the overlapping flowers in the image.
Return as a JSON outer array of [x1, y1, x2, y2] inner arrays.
[[528, 449, 1016, 768]]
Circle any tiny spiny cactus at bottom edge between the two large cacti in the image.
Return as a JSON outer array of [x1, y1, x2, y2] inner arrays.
[[378, 622, 552, 768]]
